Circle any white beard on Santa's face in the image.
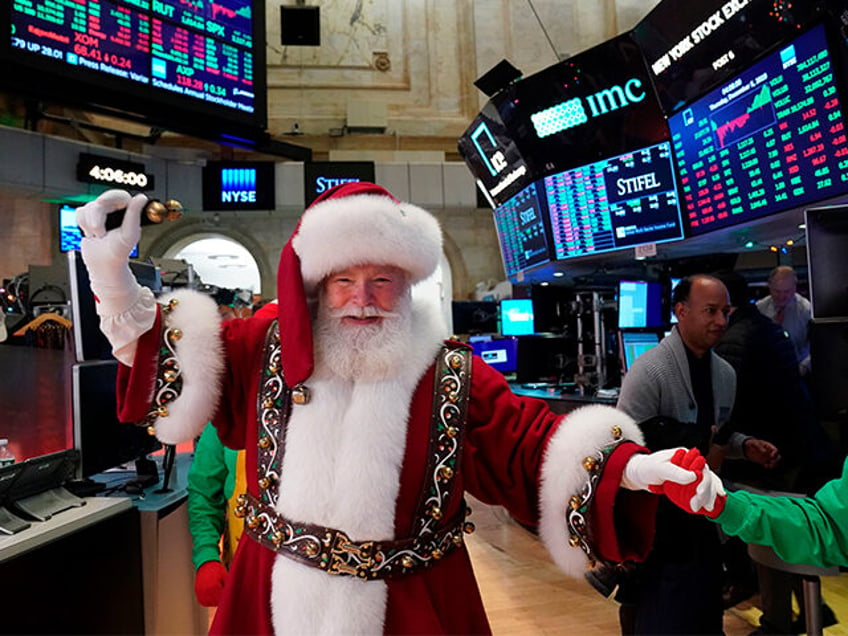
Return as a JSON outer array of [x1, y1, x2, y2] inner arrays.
[[314, 295, 412, 381]]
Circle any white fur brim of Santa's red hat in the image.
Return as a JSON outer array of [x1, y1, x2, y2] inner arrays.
[[292, 194, 442, 290]]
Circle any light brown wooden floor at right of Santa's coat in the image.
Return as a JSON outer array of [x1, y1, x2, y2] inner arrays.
[[467, 499, 848, 636]]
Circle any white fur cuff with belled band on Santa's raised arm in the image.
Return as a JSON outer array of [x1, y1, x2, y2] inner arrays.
[[139, 290, 223, 444]]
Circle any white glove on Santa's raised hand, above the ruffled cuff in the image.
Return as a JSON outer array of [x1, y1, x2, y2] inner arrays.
[[77, 190, 148, 316]]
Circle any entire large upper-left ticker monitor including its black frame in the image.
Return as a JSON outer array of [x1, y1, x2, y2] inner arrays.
[[0, 0, 267, 140]]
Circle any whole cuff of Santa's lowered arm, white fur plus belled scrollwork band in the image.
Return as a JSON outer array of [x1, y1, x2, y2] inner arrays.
[[539, 405, 642, 578]]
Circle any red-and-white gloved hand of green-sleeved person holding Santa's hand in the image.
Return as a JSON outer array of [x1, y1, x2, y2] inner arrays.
[[651, 448, 727, 519]]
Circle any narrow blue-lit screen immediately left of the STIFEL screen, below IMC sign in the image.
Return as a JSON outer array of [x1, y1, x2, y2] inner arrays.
[[494, 183, 551, 280]]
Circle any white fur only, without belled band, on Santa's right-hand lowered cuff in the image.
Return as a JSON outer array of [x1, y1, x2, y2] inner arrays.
[[539, 404, 643, 577]]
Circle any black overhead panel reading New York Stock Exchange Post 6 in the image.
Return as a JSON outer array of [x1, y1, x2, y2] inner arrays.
[[632, 0, 828, 113]]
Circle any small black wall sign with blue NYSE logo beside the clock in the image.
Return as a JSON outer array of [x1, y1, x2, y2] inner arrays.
[[203, 161, 275, 211]]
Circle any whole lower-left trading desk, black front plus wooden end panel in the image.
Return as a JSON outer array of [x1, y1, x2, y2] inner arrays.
[[0, 453, 209, 634]]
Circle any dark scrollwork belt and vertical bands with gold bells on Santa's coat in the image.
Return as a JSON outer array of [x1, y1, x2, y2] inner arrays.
[[240, 338, 474, 580]]
